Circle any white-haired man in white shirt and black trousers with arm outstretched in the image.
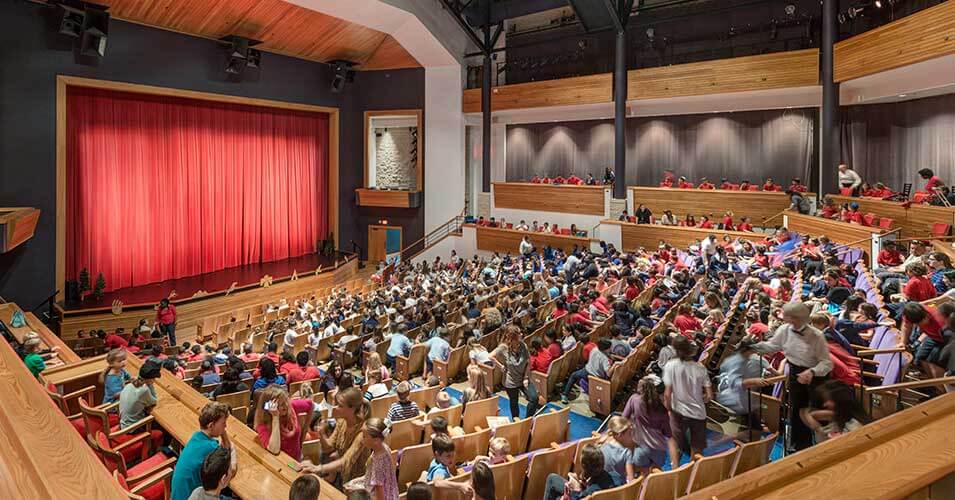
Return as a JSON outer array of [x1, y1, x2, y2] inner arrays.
[[753, 302, 832, 451]]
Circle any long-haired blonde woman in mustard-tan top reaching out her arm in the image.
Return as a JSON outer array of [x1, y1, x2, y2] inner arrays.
[[304, 387, 371, 483]]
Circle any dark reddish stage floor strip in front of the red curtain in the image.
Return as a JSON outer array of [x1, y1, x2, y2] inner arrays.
[[59, 252, 354, 311]]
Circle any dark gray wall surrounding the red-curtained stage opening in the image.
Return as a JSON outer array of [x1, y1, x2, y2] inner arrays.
[[0, 0, 424, 307]]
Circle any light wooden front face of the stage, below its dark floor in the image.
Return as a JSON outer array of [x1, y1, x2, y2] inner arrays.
[[60, 259, 358, 339]]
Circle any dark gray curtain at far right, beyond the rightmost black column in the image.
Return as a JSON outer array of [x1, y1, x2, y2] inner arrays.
[[833, 94, 955, 190]]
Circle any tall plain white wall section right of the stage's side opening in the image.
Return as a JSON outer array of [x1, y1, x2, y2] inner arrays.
[[424, 65, 464, 234]]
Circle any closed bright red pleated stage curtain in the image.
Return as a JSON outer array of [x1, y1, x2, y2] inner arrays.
[[66, 88, 328, 291]]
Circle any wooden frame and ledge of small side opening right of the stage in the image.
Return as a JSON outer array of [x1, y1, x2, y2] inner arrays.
[[355, 109, 424, 208]]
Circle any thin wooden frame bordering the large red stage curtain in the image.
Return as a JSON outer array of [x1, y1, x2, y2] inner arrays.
[[55, 75, 341, 300]]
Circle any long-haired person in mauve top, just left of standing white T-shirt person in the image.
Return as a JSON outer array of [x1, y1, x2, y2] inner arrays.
[[623, 375, 675, 475]]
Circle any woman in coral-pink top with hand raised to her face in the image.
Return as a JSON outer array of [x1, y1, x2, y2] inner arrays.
[[253, 385, 312, 460]]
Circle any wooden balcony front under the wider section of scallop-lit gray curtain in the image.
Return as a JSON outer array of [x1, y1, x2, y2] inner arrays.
[[629, 186, 814, 226]]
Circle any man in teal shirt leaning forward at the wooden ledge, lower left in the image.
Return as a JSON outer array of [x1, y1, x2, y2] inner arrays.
[[172, 402, 233, 500]]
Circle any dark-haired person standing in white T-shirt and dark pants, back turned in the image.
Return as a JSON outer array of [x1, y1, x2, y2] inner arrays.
[[663, 335, 713, 464]]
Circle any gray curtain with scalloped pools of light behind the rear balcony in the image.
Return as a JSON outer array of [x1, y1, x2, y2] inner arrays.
[[507, 108, 818, 186]]
